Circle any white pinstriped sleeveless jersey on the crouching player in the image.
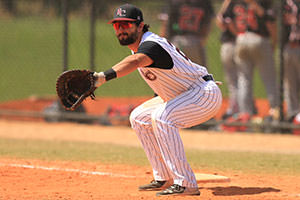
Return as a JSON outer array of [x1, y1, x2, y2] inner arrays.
[[138, 32, 208, 101]]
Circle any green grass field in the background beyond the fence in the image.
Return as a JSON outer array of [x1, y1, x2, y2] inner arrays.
[[0, 16, 265, 102]]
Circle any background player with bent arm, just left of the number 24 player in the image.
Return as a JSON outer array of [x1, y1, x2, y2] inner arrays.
[[216, 0, 257, 119]]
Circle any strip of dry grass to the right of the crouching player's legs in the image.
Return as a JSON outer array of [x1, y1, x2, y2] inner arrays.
[[187, 150, 300, 175]]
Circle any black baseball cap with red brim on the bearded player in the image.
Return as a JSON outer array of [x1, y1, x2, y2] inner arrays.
[[108, 4, 144, 24]]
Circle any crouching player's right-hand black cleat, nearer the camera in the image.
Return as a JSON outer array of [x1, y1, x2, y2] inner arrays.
[[156, 184, 200, 196]]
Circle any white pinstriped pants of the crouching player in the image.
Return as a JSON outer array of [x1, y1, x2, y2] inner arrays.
[[130, 81, 222, 188]]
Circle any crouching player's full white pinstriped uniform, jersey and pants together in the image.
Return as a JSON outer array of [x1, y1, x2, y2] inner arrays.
[[130, 32, 222, 188]]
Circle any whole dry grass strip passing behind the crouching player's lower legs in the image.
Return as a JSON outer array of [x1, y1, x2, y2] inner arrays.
[[0, 138, 300, 175]]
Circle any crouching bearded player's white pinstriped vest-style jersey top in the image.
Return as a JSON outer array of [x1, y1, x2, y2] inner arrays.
[[136, 32, 208, 101]]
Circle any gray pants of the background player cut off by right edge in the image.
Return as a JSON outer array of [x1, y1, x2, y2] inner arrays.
[[283, 45, 300, 118]]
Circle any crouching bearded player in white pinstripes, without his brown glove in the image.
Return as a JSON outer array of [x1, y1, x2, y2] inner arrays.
[[94, 4, 222, 196]]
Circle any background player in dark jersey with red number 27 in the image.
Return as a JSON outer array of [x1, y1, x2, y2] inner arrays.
[[160, 0, 214, 66]]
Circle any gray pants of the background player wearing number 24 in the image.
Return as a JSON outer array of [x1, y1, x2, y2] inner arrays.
[[235, 32, 279, 113]]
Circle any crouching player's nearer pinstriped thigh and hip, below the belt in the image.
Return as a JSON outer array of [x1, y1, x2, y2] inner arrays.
[[152, 81, 222, 128]]
